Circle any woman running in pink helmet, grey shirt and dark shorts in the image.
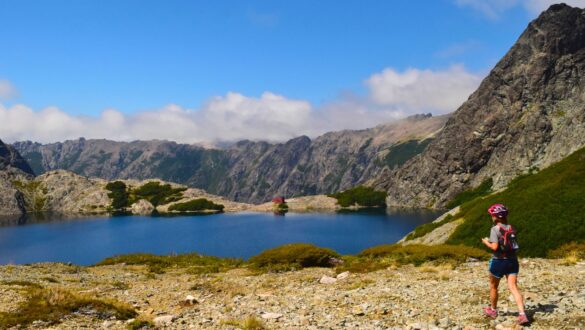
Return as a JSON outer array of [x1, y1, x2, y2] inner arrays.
[[482, 204, 528, 325]]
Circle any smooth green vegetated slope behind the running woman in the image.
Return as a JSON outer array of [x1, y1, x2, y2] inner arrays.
[[447, 148, 585, 257]]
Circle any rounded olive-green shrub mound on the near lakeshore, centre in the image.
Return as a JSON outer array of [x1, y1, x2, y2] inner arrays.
[[250, 243, 340, 271]]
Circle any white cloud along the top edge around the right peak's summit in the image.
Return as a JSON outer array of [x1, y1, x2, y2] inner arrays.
[[455, 0, 585, 19]]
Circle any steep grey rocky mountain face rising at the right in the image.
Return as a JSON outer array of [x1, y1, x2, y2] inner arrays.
[[372, 4, 585, 207]]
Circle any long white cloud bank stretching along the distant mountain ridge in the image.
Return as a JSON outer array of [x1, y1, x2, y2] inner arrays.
[[0, 65, 482, 145]]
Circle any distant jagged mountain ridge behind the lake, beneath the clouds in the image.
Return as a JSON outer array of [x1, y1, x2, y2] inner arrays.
[[14, 115, 447, 203]]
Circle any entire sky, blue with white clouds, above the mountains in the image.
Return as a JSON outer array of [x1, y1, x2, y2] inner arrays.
[[0, 0, 585, 145]]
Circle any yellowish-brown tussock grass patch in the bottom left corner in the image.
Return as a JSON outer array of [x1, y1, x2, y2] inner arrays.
[[0, 285, 137, 329]]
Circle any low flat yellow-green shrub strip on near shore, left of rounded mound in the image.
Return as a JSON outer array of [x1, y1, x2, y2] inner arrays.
[[96, 253, 242, 274]]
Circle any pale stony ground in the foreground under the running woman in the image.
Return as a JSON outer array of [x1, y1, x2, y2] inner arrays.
[[0, 259, 585, 329]]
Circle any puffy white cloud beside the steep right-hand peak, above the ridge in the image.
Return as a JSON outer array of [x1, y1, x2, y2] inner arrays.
[[366, 65, 483, 113]]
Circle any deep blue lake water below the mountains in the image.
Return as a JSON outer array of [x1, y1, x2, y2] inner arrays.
[[0, 210, 437, 265]]
